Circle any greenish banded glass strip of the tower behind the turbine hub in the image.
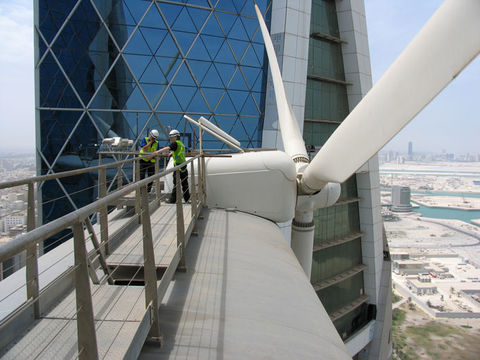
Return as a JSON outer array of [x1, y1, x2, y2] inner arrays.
[[303, 0, 367, 339]]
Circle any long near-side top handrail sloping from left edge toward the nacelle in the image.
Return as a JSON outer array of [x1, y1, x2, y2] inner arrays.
[[0, 154, 202, 262]]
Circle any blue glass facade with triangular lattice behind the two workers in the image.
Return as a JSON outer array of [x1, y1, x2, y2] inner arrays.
[[35, 0, 271, 239]]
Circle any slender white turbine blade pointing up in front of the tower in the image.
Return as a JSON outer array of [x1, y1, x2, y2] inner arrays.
[[255, 4, 308, 162]]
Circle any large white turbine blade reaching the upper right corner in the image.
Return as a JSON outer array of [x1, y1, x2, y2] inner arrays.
[[302, 0, 480, 192]]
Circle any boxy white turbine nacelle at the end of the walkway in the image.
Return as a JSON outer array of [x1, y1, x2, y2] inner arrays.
[[205, 151, 297, 222]]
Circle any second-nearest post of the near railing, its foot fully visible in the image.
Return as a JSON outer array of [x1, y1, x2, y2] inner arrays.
[[140, 186, 160, 341]]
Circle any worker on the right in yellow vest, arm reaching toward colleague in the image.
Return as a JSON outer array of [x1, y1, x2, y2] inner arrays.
[[156, 129, 190, 204]]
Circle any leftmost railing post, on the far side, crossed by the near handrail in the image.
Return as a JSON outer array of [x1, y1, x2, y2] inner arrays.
[[26, 183, 40, 319]]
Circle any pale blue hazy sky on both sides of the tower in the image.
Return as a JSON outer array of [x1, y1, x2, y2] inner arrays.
[[0, 0, 480, 153]]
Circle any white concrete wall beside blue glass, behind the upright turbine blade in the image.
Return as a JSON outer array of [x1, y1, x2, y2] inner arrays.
[[262, 0, 311, 150]]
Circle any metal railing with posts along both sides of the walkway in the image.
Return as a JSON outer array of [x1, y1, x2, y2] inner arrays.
[[0, 153, 206, 359]]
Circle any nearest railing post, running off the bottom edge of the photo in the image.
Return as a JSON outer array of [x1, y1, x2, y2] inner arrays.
[[73, 222, 98, 360]]
